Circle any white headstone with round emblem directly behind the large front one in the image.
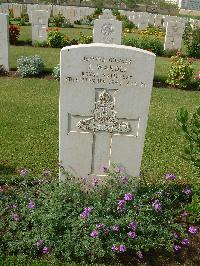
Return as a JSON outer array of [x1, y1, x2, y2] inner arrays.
[[93, 9, 122, 44]]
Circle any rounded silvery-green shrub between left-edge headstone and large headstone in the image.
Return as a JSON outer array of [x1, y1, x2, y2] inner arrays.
[[17, 55, 44, 77]]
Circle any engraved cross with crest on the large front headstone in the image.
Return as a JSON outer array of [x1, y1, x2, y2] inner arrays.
[[67, 89, 140, 176]]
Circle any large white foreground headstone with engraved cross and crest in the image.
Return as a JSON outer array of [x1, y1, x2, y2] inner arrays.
[[59, 43, 155, 180]]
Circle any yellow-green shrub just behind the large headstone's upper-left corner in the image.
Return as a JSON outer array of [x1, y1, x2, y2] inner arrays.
[[47, 28, 68, 48]]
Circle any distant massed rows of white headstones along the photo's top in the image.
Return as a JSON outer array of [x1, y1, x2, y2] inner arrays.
[[0, 3, 200, 29]]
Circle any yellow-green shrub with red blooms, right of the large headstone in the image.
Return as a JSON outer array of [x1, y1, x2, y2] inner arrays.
[[166, 53, 194, 89]]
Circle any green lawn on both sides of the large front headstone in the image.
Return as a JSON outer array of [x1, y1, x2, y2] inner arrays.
[[0, 77, 200, 182]]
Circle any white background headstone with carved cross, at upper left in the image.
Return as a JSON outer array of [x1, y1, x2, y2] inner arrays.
[[31, 10, 49, 42]]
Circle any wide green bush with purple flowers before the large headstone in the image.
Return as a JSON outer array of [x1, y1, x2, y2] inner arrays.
[[0, 166, 198, 263]]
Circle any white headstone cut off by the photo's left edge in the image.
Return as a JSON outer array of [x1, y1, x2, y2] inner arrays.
[[0, 13, 9, 71]]
